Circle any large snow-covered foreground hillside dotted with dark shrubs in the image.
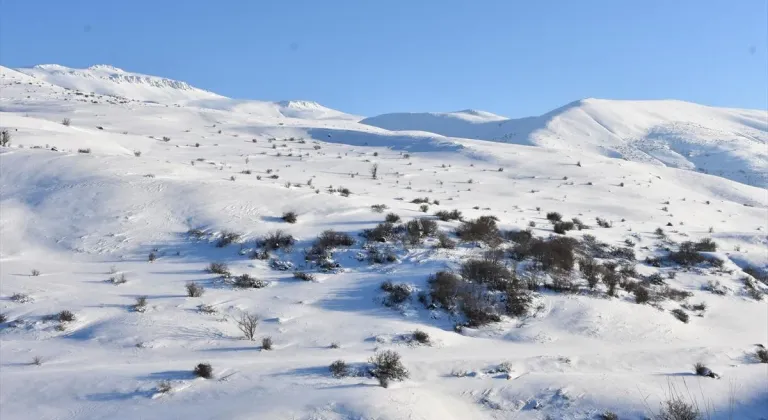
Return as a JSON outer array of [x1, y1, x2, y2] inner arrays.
[[0, 68, 768, 420]]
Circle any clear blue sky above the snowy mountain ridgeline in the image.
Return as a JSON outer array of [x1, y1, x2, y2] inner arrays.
[[0, 0, 768, 117]]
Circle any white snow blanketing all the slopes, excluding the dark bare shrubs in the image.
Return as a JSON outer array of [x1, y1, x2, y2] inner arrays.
[[0, 65, 768, 420]]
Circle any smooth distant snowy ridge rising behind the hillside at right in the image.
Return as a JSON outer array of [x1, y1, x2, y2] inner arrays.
[[361, 99, 768, 187]]
